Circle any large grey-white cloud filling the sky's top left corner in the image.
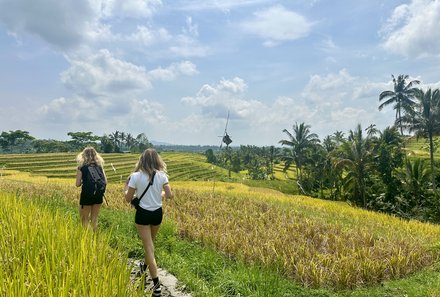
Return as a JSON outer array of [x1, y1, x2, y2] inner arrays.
[[0, 0, 203, 57]]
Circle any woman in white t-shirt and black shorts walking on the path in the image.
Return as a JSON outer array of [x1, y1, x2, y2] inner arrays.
[[125, 149, 173, 296]]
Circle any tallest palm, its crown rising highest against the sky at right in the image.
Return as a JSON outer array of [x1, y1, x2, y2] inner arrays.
[[379, 74, 420, 136]]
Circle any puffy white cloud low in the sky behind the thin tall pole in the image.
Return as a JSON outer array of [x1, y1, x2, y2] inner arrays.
[[180, 77, 322, 145]]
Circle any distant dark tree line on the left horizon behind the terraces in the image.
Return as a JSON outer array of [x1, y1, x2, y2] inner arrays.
[[0, 130, 153, 154]]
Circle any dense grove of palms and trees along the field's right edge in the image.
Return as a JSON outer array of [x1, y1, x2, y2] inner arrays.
[[207, 75, 440, 222]]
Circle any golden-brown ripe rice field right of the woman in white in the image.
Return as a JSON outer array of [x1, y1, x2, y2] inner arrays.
[[170, 183, 440, 289]]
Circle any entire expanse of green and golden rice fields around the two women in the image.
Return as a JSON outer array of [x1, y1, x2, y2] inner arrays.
[[0, 148, 440, 296]]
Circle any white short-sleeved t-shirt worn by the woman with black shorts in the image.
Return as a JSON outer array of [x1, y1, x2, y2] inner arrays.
[[128, 171, 168, 211]]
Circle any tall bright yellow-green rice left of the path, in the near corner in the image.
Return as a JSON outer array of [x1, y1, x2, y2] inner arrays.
[[0, 193, 142, 297]]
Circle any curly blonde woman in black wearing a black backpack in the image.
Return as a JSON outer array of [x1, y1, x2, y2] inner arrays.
[[76, 146, 107, 230]]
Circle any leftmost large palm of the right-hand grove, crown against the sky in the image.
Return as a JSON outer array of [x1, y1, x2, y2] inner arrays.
[[279, 123, 319, 185]]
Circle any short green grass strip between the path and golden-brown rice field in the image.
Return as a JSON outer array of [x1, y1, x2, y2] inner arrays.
[[0, 151, 440, 296]]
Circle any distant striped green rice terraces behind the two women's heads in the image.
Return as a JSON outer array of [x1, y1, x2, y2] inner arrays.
[[0, 152, 234, 182]]
